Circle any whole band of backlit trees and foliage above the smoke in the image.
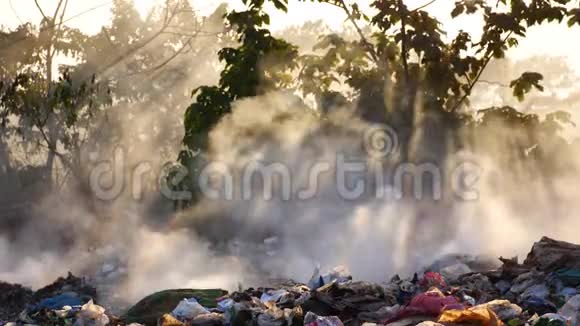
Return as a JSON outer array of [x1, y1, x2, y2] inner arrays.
[[0, 0, 580, 204]]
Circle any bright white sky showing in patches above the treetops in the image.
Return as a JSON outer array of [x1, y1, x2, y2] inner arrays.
[[0, 0, 580, 71]]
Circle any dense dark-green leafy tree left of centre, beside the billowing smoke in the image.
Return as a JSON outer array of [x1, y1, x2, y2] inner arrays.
[[181, 1, 297, 154]]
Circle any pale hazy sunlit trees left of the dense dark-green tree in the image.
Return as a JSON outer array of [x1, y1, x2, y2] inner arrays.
[[0, 0, 230, 197]]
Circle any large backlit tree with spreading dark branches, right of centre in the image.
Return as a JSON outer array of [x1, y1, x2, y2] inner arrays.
[[303, 0, 575, 158]]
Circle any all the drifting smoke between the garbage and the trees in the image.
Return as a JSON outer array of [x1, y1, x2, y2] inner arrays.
[[0, 5, 580, 312]]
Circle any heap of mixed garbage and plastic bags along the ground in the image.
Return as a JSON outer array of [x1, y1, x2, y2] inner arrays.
[[0, 238, 580, 326]]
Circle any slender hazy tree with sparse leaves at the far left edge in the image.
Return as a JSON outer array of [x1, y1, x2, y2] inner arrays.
[[0, 0, 106, 187]]
